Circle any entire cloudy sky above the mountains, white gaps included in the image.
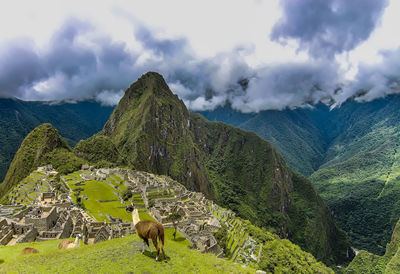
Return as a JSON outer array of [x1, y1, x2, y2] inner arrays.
[[0, 0, 400, 112]]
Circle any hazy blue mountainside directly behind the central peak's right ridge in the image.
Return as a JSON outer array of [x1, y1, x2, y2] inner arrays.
[[199, 106, 329, 176]]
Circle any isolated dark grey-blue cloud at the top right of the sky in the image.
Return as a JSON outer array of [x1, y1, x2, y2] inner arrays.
[[271, 0, 388, 57]]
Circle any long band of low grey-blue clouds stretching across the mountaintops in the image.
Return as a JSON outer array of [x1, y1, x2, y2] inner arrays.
[[0, 14, 400, 112]]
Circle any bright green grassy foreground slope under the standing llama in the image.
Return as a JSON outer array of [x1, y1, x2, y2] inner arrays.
[[0, 233, 255, 273]]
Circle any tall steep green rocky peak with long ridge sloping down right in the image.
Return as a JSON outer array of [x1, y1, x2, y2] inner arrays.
[[79, 73, 351, 264]]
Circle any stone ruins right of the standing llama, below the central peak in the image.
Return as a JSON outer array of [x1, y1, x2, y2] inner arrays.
[[123, 171, 222, 255]]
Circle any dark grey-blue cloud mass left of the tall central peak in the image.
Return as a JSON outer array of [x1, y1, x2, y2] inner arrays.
[[0, 19, 140, 103]]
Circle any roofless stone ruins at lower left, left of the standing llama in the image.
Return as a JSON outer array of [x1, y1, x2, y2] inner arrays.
[[0, 193, 135, 245]]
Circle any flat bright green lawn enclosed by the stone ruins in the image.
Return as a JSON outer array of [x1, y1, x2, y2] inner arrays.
[[66, 173, 131, 221]]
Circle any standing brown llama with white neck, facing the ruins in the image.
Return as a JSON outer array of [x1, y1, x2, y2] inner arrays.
[[126, 202, 167, 262]]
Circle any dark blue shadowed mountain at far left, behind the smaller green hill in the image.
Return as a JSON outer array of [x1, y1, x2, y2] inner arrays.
[[0, 98, 113, 182]]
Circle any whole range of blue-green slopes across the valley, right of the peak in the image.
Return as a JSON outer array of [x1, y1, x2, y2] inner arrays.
[[203, 95, 400, 254]]
